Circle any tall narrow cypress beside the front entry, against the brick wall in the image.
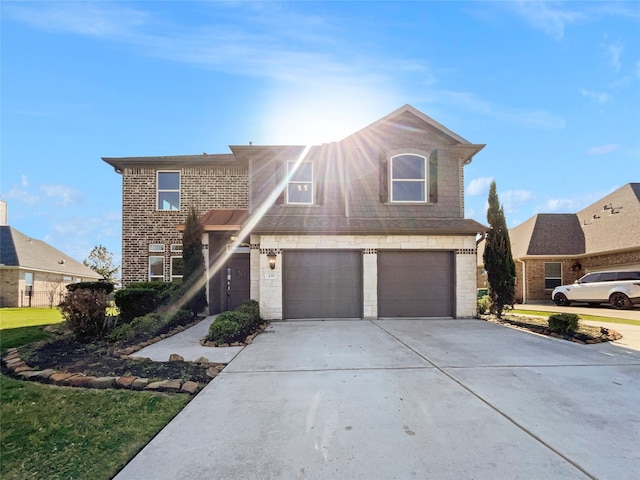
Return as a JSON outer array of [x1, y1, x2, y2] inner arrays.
[[180, 207, 207, 316]]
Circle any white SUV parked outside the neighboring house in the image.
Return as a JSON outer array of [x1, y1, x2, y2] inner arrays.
[[551, 270, 640, 308]]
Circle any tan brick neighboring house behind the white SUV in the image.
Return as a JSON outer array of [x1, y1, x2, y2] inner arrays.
[[478, 183, 640, 303]]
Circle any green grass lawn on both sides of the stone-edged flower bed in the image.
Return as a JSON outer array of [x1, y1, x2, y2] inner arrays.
[[0, 308, 191, 480]]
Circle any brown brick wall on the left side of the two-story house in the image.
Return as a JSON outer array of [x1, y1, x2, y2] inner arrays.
[[122, 167, 249, 285]]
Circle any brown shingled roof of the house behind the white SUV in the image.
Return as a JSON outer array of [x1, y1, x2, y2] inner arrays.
[[509, 183, 640, 258]]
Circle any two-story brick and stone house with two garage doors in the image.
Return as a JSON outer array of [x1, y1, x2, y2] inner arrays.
[[103, 105, 486, 319]]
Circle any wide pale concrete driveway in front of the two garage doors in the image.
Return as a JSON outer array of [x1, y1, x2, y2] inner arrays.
[[116, 319, 640, 480]]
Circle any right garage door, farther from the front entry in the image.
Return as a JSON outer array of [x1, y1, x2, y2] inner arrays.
[[378, 251, 455, 317]]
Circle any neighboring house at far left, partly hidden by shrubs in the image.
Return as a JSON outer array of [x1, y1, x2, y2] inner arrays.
[[0, 225, 101, 307]]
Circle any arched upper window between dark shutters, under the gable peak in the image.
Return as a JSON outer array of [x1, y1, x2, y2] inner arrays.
[[390, 154, 427, 202]]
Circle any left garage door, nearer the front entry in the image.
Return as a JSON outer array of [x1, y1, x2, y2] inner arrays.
[[282, 250, 362, 318]]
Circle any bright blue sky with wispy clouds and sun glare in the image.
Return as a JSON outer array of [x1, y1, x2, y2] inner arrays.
[[0, 0, 640, 270]]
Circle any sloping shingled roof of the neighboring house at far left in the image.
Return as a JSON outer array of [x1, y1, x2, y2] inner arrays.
[[0, 226, 102, 280]]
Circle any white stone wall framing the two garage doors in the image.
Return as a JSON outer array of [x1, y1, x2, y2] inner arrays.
[[251, 235, 477, 320]]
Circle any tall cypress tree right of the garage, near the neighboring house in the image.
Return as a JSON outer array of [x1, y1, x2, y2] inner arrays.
[[482, 181, 516, 318]]
